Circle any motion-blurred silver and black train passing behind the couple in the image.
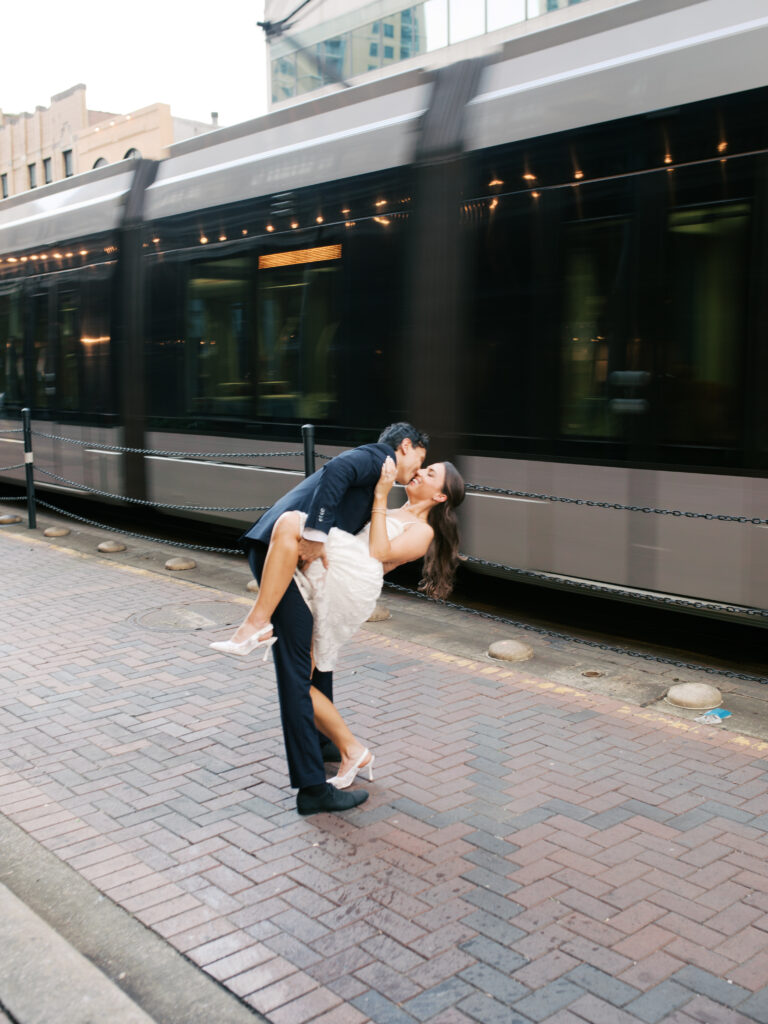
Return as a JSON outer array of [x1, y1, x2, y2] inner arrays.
[[0, 0, 768, 608]]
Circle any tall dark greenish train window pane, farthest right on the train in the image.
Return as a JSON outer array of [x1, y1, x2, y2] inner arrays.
[[659, 203, 750, 445]]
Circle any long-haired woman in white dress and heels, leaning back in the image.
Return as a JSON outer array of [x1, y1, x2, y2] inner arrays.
[[210, 459, 464, 790]]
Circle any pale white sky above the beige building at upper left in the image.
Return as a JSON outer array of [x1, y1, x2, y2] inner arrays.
[[0, 0, 267, 125]]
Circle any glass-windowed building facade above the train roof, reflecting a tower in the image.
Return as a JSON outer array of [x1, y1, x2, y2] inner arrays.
[[265, 0, 594, 108]]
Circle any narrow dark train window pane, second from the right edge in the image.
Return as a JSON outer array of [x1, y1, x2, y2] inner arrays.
[[560, 218, 630, 437]]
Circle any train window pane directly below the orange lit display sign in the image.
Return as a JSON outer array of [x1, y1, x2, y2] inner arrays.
[[258, 256, 341, 420]]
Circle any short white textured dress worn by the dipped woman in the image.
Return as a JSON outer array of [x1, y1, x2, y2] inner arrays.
[[294, 512, 407, 672]]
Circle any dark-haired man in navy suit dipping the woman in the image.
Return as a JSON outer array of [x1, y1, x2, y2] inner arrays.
[[243, 423, 428, 814]]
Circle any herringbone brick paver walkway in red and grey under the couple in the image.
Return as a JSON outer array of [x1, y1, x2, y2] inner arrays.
[[0, 535, 768, 1024]]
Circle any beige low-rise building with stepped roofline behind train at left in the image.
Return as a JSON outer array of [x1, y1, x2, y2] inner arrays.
[[0, 84, 217, 200]]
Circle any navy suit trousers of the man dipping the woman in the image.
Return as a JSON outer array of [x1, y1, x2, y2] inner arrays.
[[248, 542, 333, 790]]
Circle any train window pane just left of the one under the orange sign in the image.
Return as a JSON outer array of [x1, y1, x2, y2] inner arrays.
[[184, 258, 253, 416]]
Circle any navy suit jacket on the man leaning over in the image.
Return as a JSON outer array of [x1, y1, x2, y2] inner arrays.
[[243, 443, 395, 545]]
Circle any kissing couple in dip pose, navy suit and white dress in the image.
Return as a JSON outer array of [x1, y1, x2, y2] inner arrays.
[[211, 423, 464, 814]]
